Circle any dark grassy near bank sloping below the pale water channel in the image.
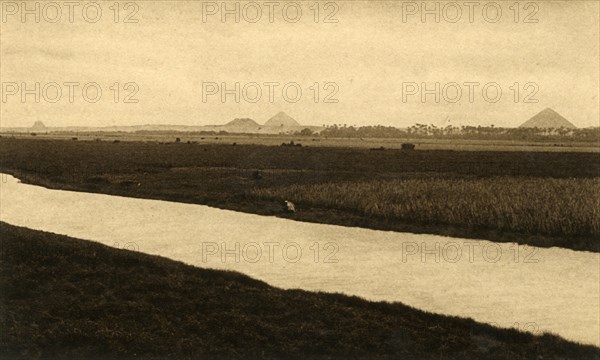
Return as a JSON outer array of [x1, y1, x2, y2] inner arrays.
[[0, 223, 600, 359]]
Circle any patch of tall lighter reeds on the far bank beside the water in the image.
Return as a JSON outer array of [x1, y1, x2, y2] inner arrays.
[[250, 177, 600, 236]]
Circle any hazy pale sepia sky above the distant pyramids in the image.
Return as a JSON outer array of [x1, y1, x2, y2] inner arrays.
[[0, 1, 600, 127]]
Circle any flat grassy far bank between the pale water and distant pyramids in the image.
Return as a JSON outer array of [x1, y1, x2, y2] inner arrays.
[[0, 138, 600, 251]]
